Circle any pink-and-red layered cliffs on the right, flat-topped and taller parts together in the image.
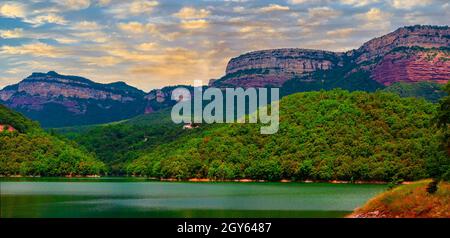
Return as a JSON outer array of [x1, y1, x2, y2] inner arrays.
[[210, 26, 450, 87]]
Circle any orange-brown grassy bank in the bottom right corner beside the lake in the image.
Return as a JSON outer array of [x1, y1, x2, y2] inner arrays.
[[349, 180, 450, 218]]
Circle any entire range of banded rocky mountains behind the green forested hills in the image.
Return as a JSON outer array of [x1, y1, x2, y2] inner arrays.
[[0, 26, 450, 127]]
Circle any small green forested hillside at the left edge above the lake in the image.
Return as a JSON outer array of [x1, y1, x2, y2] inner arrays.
[[0, 105, 107, 176]]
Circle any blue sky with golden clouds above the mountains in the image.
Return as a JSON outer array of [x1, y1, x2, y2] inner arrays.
[[0, 0, 450, 91]]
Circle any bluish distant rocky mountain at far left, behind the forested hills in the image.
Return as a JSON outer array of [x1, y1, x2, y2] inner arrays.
[[0, 71, 146, 127]]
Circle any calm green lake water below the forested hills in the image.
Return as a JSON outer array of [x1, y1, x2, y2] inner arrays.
[[0, 178, 386, 218]]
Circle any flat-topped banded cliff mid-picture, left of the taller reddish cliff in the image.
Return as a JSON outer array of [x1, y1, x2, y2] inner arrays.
[[211, 49, 343, 87]]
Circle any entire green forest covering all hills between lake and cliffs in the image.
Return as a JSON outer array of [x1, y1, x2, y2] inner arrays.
[[0, 86, 450, 181]]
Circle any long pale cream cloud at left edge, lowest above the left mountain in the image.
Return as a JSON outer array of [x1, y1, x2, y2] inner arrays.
[[0, 42, 66, 58]]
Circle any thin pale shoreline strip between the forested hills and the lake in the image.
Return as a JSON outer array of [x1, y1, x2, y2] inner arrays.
[[0, 175, 402, 185]]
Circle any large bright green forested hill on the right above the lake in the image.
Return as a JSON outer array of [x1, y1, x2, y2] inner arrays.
[[127, 90, 450, 181]]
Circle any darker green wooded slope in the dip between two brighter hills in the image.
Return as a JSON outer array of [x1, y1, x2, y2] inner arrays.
[[65, 109, 187, 175]]
